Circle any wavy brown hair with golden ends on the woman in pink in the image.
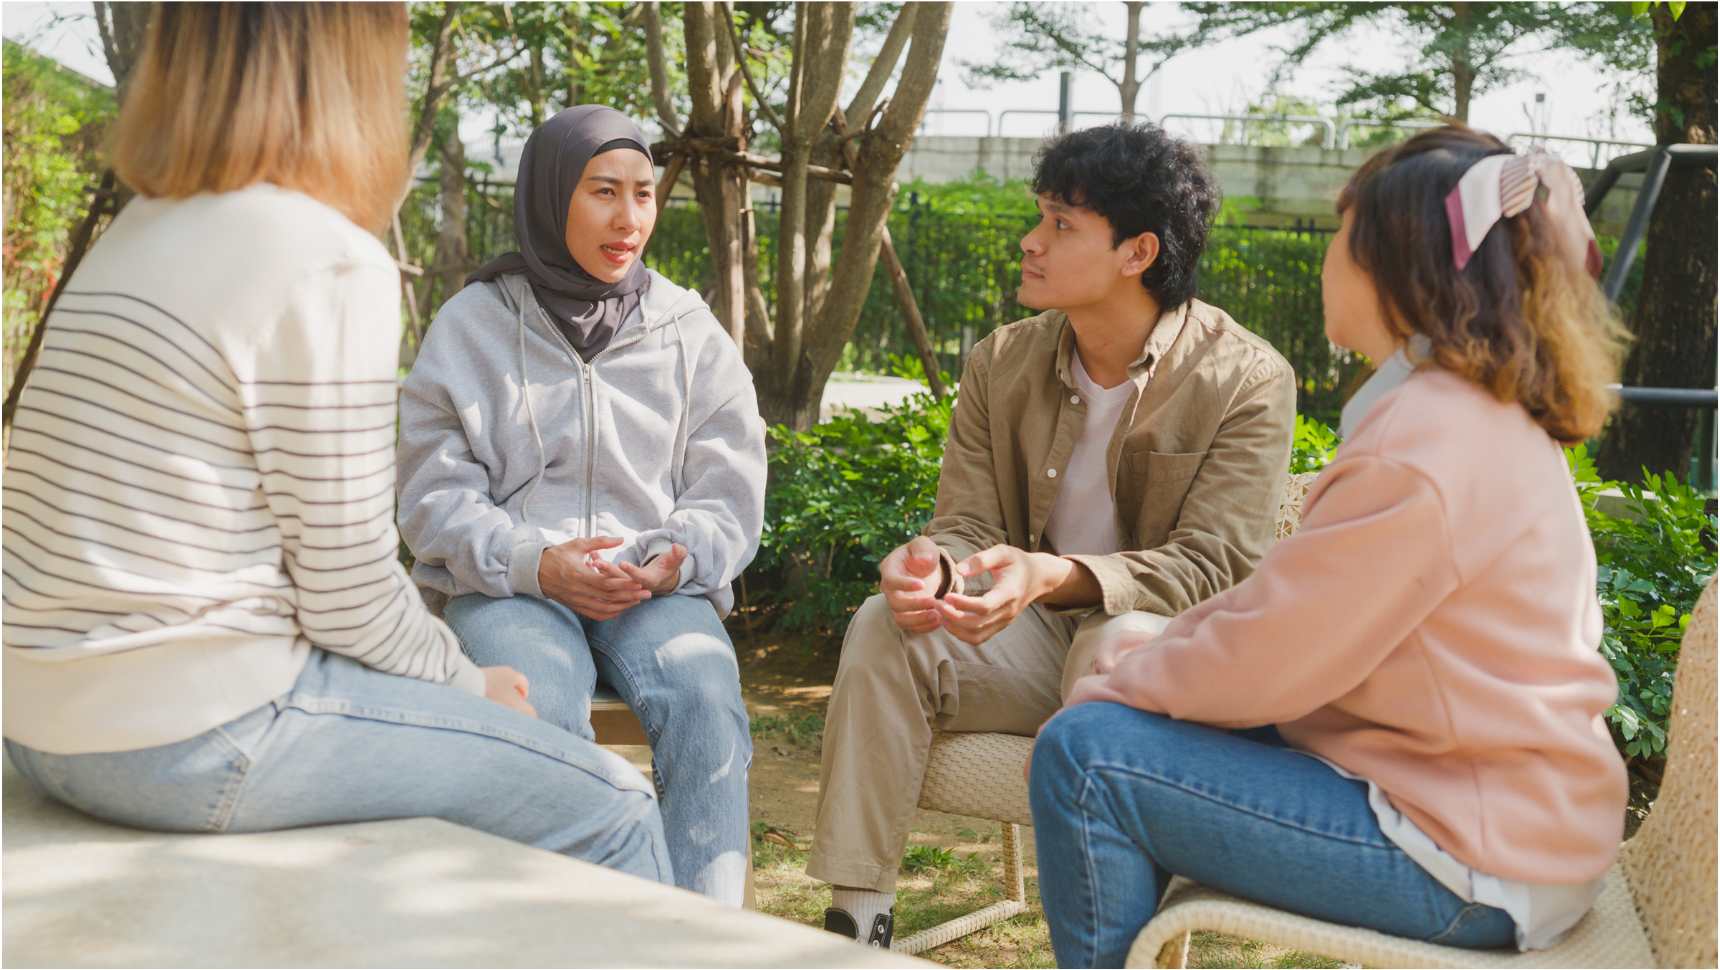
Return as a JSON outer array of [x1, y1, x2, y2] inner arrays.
[[1338, 124, 1629, 444]]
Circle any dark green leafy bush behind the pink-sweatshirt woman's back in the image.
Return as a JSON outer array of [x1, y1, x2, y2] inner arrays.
[[1565, 445, 1715, 758]]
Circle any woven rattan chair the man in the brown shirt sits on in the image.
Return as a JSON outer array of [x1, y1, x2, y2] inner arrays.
[[893, 473, 1316, 953]]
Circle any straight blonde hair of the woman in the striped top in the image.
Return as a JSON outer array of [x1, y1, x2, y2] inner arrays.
[[108, 3, 409, 230]]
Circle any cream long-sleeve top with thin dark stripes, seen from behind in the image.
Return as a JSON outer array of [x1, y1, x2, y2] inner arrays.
[[0, 186, 483, 753]]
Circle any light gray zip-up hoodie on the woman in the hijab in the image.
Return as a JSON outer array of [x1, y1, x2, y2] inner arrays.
[[399, 272, 765, 614]]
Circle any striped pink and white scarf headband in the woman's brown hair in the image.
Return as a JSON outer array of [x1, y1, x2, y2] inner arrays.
[[1445, 150, 1601, 279]]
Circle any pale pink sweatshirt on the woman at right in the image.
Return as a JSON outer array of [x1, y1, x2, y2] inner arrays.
[[1068, 368, 1627, 884]]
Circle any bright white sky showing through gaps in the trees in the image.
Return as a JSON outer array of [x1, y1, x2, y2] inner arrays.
[[0, 0, 1653, 162]]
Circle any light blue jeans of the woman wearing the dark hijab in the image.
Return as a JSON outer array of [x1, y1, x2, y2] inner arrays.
[[444, 593, 752, 906]]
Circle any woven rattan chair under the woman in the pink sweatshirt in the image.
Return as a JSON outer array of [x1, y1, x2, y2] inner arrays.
[[1125, 581, 1720, 967]]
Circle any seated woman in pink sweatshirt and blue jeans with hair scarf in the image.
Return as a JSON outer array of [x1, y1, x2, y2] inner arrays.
[[1032, 127, 1625, 967]]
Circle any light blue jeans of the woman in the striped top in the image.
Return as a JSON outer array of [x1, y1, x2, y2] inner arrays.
[[5, 648, 673, 882]]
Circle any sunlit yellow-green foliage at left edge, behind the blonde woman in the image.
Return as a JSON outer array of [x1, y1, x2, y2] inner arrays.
[[0, 41, 114, 385]]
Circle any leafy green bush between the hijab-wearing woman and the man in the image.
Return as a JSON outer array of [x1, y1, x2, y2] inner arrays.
[[748, 394, 953, 631]]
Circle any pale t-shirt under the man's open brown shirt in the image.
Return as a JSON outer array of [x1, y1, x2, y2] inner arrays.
[[1046, 351, 1135, 556]]
